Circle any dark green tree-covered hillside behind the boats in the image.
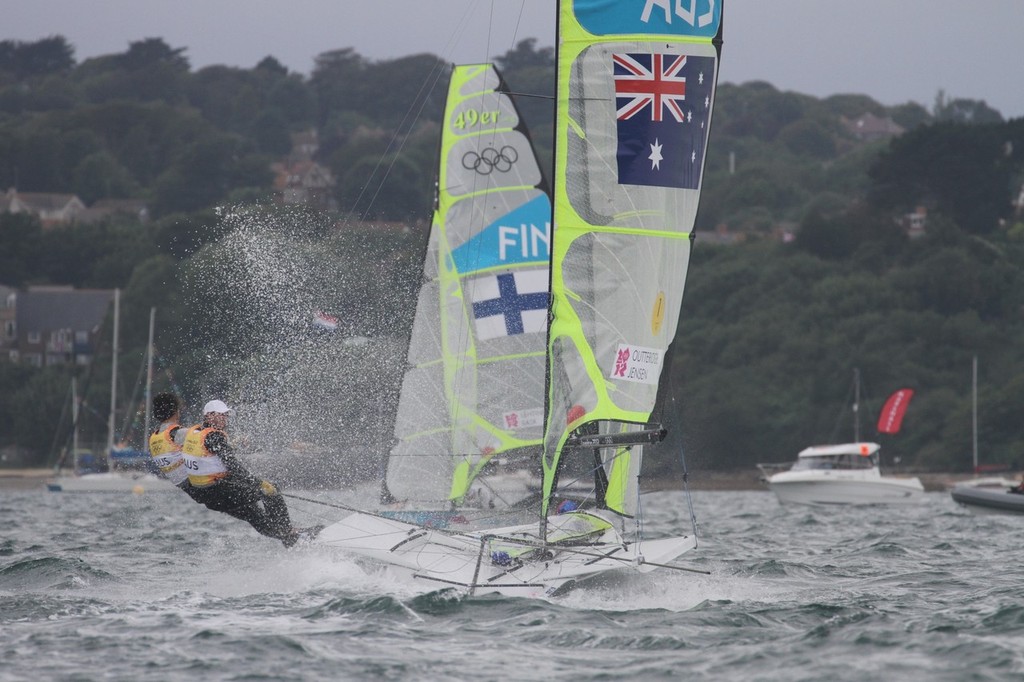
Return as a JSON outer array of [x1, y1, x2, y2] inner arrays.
[[0, 37, 1024, 475]]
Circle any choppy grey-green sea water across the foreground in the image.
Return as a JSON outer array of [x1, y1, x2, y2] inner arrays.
[[0, 489, 1024, 682]]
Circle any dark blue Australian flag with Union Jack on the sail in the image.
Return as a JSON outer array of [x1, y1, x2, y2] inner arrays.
[[611, 53, 715, 189]]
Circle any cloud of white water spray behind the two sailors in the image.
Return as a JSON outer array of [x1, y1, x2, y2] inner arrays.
[[183, 201, 422, 487]]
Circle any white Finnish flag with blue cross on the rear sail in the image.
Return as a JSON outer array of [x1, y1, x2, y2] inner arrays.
[[469, 268, 549, 341]]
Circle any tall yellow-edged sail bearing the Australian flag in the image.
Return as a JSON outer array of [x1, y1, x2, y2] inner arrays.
[[544, 0, 721, 515]]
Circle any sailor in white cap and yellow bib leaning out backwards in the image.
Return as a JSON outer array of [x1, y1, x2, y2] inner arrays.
[[181, 400, 308, 547]]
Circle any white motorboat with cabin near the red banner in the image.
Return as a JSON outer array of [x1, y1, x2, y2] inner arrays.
[[766, 442, 925, 505]]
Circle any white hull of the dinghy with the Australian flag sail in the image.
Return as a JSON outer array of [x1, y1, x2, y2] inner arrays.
[[315, 503, 696, 597]]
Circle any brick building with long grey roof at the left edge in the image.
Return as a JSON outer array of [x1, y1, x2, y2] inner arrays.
[[0, 287, 114, 367]]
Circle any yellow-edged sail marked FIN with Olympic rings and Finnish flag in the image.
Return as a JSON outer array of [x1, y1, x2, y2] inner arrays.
[[385, 65, 551, 508]]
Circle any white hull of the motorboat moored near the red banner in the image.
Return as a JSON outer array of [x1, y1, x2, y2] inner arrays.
[[768, 469, 925, 505]]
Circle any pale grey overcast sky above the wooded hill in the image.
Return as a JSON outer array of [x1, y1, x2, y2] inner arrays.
[[6, 0, 1024, 119]]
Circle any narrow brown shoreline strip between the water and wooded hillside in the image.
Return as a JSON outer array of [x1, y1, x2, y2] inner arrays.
[[0, 469, 999, 493]]
